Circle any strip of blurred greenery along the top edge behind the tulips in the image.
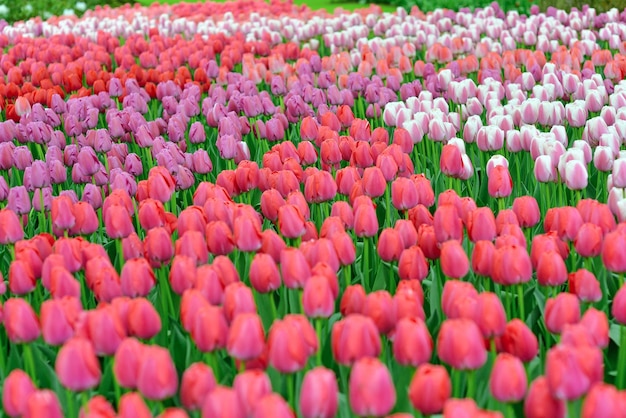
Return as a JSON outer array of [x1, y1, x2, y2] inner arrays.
[[0, 0, 626, 23]]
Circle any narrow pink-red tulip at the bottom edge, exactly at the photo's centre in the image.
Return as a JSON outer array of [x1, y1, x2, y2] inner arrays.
[[299, 367, 339, 418]]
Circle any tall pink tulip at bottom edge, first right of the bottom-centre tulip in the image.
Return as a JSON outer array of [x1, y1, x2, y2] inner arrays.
[[349, 358, 396, 417]]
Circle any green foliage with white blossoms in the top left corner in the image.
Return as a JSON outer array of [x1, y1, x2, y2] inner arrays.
[[0, 0, 135, 22]]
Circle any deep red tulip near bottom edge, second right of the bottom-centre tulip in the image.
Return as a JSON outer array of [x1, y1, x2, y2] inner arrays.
[[409, 364, 452, 415]]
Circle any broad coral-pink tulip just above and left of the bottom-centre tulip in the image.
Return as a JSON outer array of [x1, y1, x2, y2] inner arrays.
[[267, 315, 319, 373]]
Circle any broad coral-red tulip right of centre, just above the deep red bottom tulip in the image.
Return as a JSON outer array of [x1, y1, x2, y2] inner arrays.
[[437, 318, 487, 370]]
